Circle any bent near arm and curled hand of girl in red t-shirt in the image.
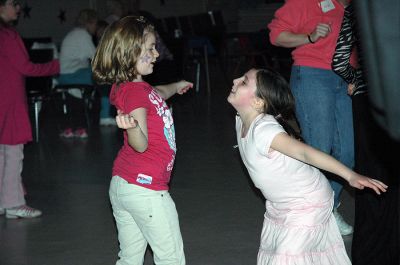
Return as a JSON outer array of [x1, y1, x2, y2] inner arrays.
[[115, 108, 148, 153]]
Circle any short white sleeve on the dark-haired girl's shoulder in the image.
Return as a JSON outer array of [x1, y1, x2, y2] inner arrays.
[[254, 118, 285, 156]]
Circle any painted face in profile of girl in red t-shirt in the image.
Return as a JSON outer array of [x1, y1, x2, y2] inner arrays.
[[136, 33, 160, 79]]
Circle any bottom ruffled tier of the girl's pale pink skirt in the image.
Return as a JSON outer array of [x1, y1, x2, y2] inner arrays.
[[257, 215, 351, 265]]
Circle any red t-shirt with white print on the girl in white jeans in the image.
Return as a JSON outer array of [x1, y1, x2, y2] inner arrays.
[[110, 82, 176, 190]]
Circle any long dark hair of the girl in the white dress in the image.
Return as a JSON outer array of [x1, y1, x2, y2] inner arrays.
[[256, 69, 302, 140]]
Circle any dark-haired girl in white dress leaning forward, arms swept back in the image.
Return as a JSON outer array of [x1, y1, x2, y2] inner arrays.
[[228, 69, 387, 265]]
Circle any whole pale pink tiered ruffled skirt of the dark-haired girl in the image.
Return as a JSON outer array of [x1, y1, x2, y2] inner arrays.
[[257, 199, 351, 265]]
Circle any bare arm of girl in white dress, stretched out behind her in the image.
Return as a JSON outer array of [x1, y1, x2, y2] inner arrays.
[[271, 133, 388, 194]]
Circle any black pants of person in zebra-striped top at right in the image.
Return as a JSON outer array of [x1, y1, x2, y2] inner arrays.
[[352, 94, 400, 265]]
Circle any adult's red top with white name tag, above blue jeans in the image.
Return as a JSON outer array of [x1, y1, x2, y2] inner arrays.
[[268, 0, 354, 70]]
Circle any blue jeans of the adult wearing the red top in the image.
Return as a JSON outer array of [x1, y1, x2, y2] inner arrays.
[[290, 66, 354, 207]]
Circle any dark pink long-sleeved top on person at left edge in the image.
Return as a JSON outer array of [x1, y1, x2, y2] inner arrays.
[[0, 26, 60, 145]]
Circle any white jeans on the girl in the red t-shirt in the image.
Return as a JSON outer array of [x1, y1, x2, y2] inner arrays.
[[109, 176, 185, 265]]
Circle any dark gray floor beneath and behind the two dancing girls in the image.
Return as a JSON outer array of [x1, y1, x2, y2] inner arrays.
[[0, 65, 354, 265]]
